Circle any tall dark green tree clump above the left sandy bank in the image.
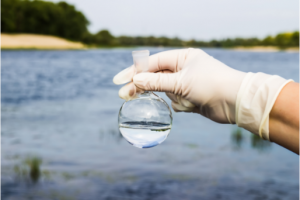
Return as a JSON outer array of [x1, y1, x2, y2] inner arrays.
[[1, 0, 89, 41]]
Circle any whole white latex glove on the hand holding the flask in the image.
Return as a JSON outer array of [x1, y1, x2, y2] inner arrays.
[[113, 48, 288, 139]]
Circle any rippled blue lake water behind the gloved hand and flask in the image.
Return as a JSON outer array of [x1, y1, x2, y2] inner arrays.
[[1, 48, 299, 200]]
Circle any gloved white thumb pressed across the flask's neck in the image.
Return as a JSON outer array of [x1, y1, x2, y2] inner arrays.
[[133, 72, 178, 93]]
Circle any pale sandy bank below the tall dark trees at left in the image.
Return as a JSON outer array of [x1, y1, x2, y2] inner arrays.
[[1, 33, 86, 49]]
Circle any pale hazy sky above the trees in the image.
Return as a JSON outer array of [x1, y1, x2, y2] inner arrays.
[[51, 0, 299, 40]]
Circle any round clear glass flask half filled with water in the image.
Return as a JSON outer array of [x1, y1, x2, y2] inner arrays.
[[118, 50, 173, 148]]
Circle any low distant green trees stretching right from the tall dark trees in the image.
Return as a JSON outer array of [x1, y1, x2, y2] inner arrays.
[[84, 30, 299, 48]]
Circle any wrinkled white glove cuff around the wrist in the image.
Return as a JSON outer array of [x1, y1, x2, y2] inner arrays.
[[235, 72, 293, 140]]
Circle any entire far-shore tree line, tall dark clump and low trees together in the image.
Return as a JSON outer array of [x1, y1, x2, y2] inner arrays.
[[1, 0, 299, 48]]
